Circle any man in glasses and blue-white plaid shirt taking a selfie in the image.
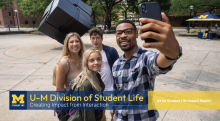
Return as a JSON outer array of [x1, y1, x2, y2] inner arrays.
[[112, 13, 182, 121]]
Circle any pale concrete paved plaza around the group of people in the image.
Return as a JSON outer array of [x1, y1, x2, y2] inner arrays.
[[0, 28, 220, 121]]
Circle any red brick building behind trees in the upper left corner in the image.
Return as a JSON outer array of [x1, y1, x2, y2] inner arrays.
[[0, 2, 41, 28]]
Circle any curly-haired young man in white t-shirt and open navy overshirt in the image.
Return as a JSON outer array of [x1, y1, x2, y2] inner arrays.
[[89, 28, 119, 121]]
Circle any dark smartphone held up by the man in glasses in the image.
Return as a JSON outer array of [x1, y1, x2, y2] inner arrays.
[[138, 2, 162, 43]]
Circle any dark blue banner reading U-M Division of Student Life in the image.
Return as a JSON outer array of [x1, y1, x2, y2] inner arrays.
[[9, 91, 148, 110]]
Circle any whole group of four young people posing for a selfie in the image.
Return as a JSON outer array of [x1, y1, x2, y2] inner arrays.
[[56, 13, 182, 121]]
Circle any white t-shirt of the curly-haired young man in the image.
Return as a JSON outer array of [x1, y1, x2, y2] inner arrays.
[[98, 50, 114, 91]]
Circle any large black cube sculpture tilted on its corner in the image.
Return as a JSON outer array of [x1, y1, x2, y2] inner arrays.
[[38, 0, 92, 44]]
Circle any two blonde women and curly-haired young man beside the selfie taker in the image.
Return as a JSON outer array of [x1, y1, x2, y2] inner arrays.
[[56, 28, 119, 121]]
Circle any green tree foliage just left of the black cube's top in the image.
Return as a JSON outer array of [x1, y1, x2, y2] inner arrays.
[[15, 0, 52, 26]]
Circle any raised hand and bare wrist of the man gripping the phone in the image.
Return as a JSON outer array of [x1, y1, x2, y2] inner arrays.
[[138, 13, 180, 68]]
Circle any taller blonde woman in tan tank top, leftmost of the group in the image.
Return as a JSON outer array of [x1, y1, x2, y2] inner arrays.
[[56, 32, 85, 91]]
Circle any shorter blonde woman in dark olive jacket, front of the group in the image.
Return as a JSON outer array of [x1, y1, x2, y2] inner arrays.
[[68, 48, 105, 121]]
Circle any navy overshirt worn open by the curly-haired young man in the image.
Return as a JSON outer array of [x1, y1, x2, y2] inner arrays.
[[103, 45, 119, 71]]
